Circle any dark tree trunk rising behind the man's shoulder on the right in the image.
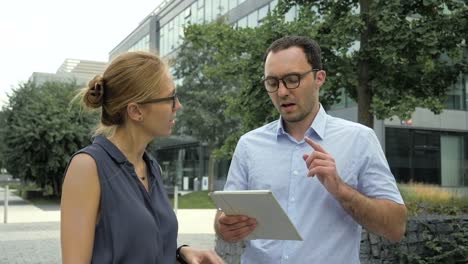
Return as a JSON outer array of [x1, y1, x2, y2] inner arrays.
[[357, 0, 374, 128]]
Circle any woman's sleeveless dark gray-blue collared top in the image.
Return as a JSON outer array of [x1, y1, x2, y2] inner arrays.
[[75, 136, 178, 264]]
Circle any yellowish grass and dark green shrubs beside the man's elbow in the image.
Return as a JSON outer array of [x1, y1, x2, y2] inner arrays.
[[391, 183, 468, 264]]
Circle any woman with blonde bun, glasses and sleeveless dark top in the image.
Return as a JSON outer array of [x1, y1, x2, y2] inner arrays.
[[61, 52, 223, 263]]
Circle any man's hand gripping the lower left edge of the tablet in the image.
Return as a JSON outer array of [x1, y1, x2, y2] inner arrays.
[[215, 212, 257, 242]]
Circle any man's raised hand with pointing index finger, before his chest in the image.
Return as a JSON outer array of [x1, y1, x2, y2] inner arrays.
[[302, 137, 343, 197]]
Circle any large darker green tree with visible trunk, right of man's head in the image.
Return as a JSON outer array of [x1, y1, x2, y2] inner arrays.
[[242, 0, 468, 127]]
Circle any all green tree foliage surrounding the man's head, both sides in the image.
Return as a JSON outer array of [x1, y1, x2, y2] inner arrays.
[[176, 0, 468, 156]]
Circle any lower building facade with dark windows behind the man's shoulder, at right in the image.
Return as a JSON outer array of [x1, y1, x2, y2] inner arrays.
[[328, 74, 468, 193]]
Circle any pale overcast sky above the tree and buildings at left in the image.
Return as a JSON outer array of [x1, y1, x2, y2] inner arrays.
[[0, 0, 163, 106]]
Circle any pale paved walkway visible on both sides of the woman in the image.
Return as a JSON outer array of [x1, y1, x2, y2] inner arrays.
[[0, 187, 216, 264]]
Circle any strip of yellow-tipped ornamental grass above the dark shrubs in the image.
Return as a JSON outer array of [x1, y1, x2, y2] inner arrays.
[[399, 183, 468, 216]]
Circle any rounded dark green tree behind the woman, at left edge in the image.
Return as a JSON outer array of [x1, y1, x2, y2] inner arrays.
[[2, 82, 96, 195]]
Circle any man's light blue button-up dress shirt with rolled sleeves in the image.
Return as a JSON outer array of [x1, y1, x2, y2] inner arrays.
[[224, 106, 403, 264]]
